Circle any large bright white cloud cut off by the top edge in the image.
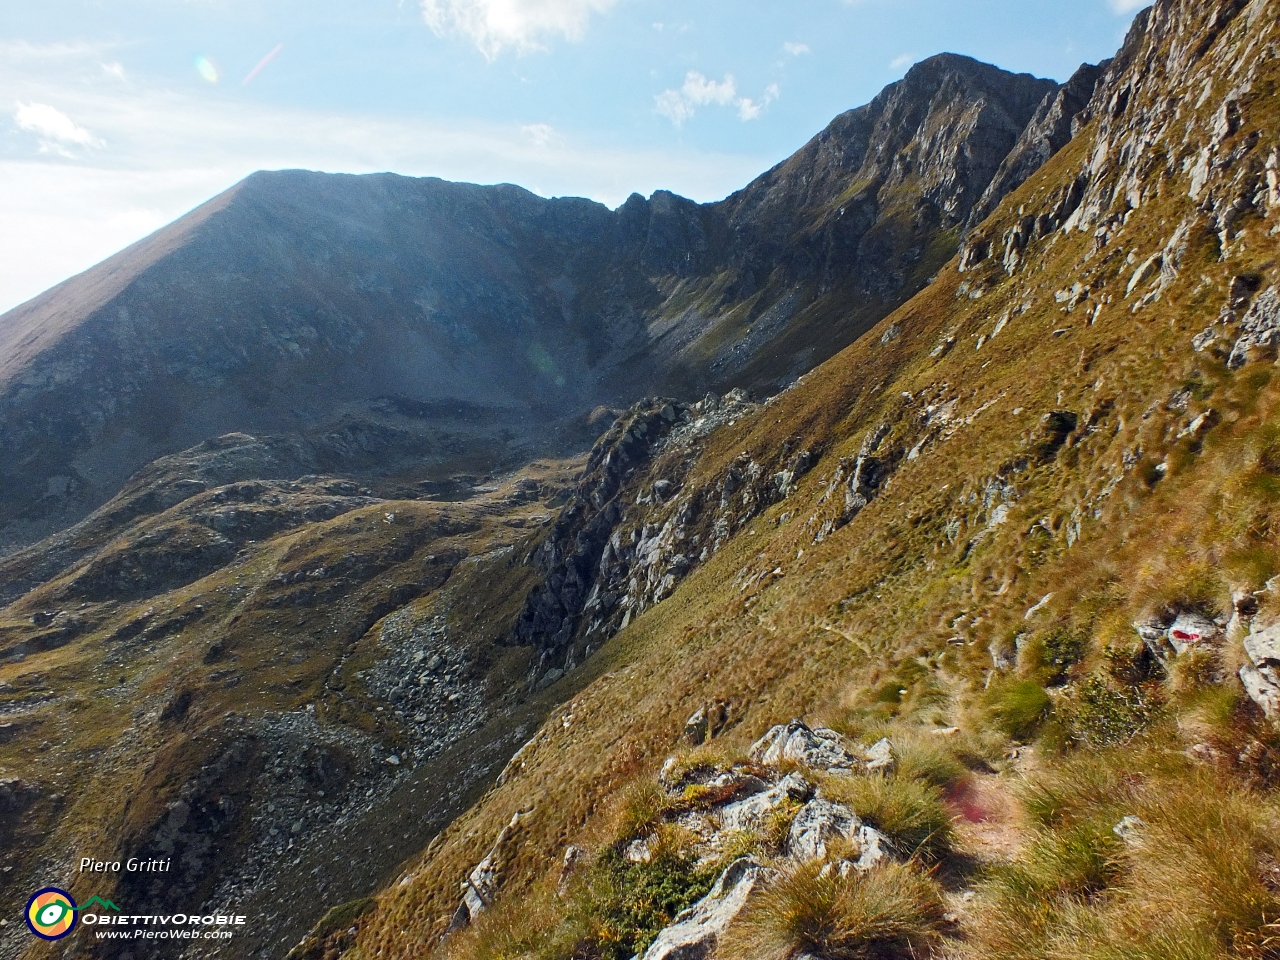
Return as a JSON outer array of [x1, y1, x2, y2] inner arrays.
[[421, 0, 616, 60]]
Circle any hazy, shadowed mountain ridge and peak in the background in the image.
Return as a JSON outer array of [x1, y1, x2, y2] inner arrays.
[[0, 55, 1100, 550]]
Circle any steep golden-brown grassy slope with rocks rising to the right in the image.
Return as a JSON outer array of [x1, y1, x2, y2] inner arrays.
[[304, 0, 1280, 957]]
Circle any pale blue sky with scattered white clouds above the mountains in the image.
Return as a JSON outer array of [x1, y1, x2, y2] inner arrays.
[[0, 0, 1140, 311]]
